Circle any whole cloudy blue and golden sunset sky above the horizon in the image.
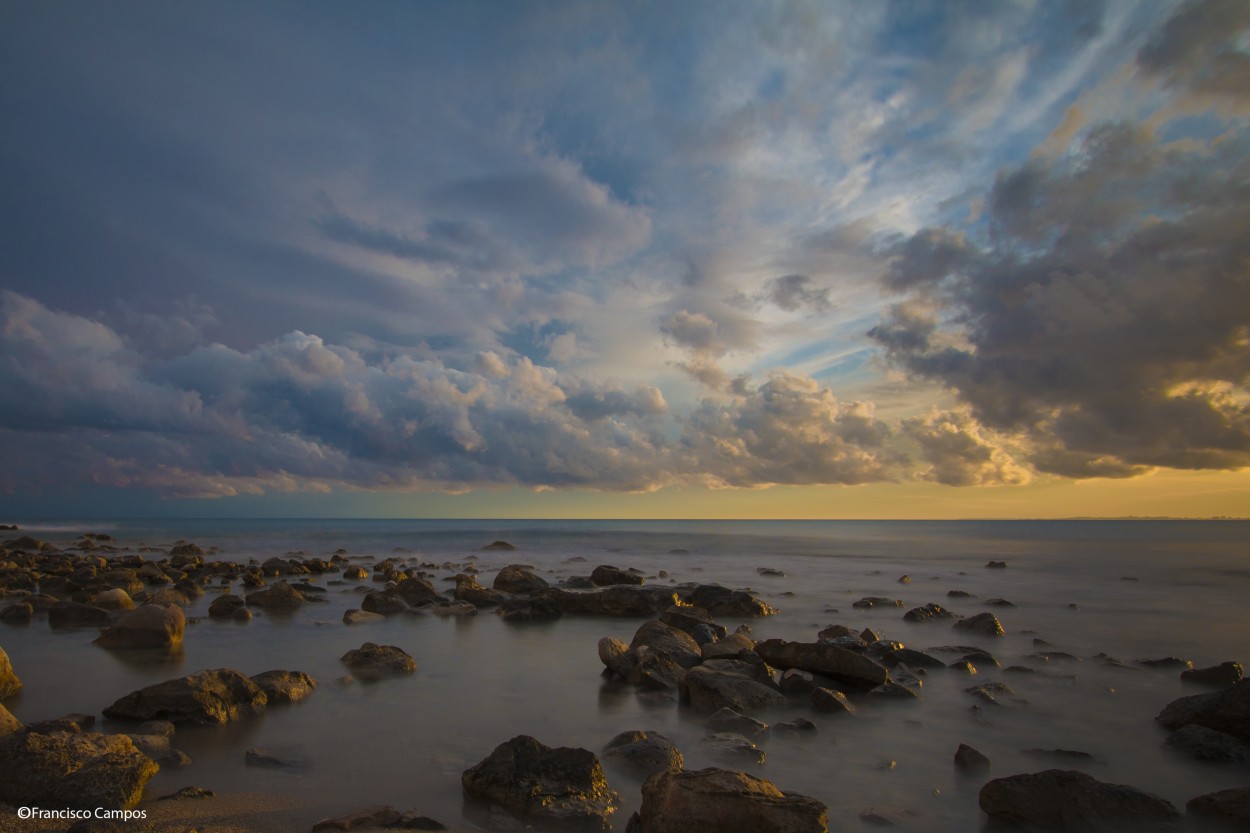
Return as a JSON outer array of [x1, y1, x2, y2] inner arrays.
[[0, 0, 1250, 518]]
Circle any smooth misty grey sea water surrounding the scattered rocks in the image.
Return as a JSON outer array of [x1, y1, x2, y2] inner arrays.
[[0, 520, 1250, 833]]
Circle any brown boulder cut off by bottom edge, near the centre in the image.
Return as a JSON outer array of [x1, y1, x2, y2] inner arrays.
[[626, 768, 829, 833]]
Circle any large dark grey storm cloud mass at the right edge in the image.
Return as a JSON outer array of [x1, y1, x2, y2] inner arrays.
[[870, 124, 1250, 477]]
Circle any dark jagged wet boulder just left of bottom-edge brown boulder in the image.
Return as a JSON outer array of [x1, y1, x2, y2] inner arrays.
[[460, 734, 620, 828]]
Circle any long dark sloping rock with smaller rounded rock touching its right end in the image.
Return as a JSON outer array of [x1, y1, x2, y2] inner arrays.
[[104, 668, 269, 723]]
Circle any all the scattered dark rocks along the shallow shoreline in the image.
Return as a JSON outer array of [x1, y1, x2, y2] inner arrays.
[[0, 534, 1250, 833]]
